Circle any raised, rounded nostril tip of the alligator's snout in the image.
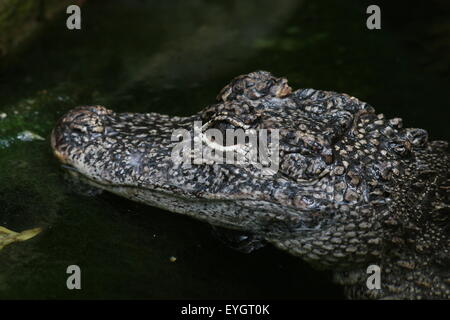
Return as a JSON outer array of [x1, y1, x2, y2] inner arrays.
[[51, 106, 112, 163]]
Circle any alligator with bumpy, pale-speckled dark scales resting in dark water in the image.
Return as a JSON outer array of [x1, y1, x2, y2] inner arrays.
[[51, 71, 450, 299]]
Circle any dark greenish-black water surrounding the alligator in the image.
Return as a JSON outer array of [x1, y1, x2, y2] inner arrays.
[[0, 0, 450, 299]]
